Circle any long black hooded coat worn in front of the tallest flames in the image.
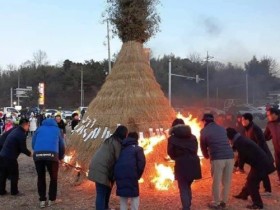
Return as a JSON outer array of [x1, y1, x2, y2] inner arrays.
[[167, 125, 201, 181]]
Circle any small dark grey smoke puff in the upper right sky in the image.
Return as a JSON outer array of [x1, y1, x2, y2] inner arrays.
[[202, 17, 222, 36]]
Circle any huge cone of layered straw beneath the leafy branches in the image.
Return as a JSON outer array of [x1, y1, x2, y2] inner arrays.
[[68, 41, 175, 180]]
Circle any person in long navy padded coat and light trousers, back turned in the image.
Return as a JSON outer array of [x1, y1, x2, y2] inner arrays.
[[114, 132, 146, 210]]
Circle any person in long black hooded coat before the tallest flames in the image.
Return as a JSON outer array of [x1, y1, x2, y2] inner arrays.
[[167, 119, 201, 210]]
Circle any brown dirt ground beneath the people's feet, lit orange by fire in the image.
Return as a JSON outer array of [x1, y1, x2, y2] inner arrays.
[[0, 140, 280, 210]]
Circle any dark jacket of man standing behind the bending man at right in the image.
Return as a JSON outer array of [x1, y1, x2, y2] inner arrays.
[[245, 122, 274, 162]]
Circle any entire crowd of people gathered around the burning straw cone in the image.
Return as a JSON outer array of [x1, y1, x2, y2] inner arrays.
[[0, 108, 280, 210]]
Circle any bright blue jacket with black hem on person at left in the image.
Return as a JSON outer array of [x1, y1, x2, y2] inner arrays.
[[32, 119, 65, 161]]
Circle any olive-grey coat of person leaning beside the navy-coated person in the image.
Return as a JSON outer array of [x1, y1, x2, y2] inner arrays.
[[88, 136, 121, 187]]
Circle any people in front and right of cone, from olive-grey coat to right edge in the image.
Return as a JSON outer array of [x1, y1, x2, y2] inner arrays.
[[88, 108, 280, 210]]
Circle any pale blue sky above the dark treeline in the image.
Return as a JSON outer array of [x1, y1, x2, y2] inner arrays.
[[0, 0, 280, 68]]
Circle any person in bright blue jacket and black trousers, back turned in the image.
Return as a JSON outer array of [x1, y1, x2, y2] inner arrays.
[[32, 118, 65, 208]]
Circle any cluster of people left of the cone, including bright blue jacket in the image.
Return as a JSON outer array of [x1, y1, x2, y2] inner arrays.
[[0, 110, 79, 208]]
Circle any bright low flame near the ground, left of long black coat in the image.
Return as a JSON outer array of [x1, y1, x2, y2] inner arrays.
[[151, 164, 174, 190]]
